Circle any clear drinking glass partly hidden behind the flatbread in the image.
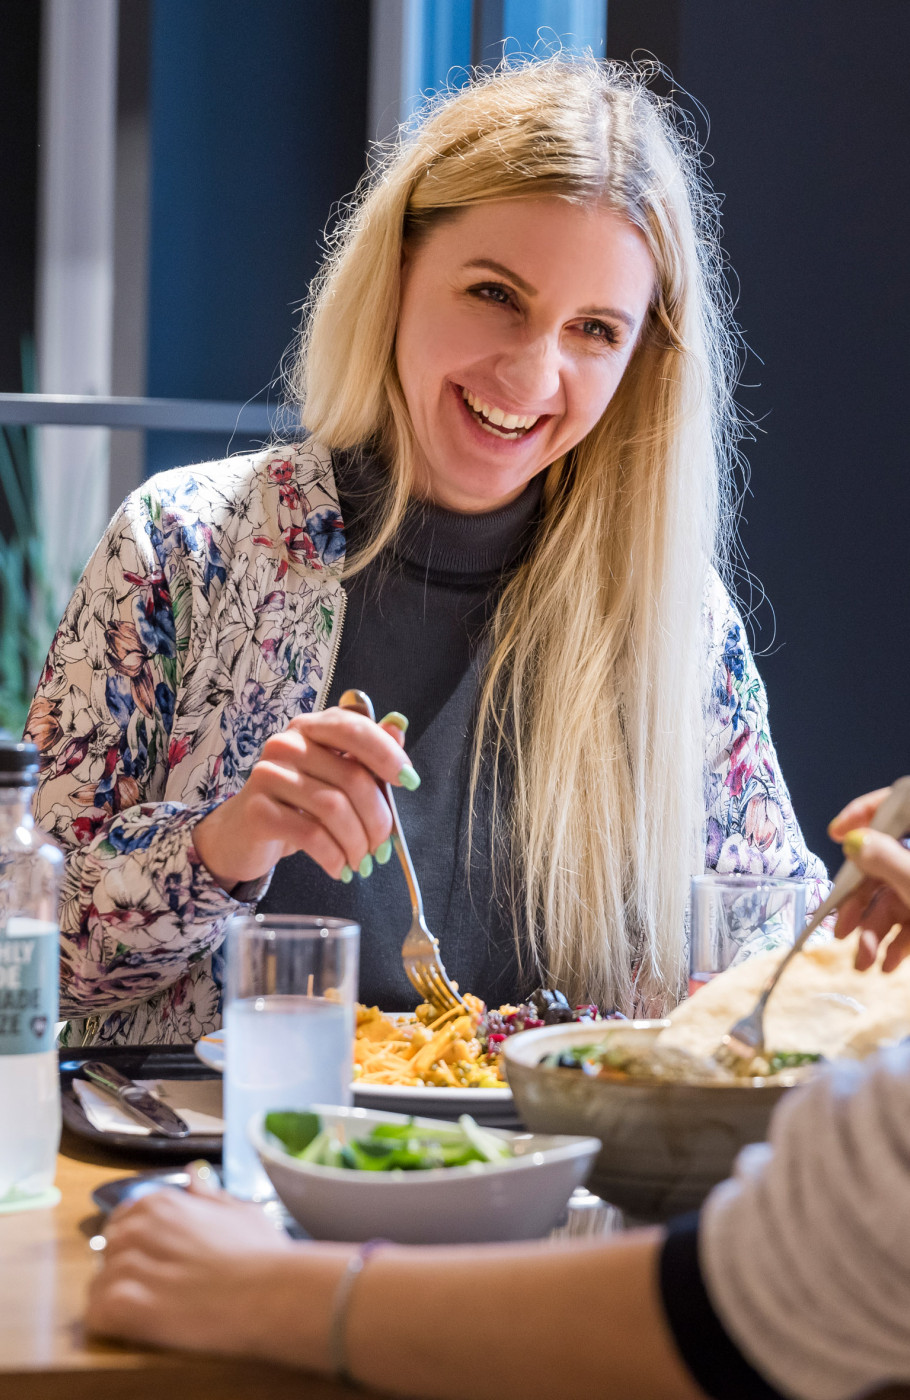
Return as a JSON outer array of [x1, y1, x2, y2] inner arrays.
[[689, 874, 806, 995]]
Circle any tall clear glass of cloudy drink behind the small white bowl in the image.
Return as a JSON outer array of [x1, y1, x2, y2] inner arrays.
[[224, 914, 360, 1201]]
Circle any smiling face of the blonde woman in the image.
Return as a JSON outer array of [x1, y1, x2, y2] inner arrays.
[[396, 199, 655, 512]]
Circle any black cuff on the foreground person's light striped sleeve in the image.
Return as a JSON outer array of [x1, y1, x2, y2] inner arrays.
[[659, 1211, 787, 1400]]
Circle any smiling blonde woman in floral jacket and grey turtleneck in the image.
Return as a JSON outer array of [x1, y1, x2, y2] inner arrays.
[[28, 59, 823, 1042]]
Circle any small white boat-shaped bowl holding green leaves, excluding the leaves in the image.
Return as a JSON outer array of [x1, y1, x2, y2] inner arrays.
[[248, 1106, 601, 1245]]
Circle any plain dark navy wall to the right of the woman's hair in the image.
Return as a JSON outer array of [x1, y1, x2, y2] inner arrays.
[[608, 0, 910, 864]]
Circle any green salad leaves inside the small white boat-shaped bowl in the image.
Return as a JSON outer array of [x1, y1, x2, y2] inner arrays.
[[265, 1112, 512, 1172]]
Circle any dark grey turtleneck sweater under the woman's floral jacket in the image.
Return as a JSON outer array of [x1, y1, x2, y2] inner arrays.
[[259, 459, 543, 1011]]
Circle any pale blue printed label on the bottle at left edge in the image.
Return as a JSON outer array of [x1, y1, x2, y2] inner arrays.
[[0, 916, 60, 1056]]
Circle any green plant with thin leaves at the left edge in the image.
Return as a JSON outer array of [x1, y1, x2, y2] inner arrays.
[[0, 340, 53, 738]]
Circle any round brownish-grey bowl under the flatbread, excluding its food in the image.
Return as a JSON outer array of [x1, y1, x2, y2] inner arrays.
[[505, 1021, 787, 1221]]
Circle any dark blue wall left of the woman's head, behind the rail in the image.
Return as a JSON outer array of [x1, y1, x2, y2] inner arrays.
[[147, 0, 368, 472]]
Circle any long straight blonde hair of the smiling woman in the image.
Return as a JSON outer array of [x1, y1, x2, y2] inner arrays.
[[295, 56, 735, 1012]]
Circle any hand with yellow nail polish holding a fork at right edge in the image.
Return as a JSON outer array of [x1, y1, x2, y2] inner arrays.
[[827, 788, 910, 972]]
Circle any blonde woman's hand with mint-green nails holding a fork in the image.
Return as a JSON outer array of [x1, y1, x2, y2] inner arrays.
[[193, 708, 420, 890]]
